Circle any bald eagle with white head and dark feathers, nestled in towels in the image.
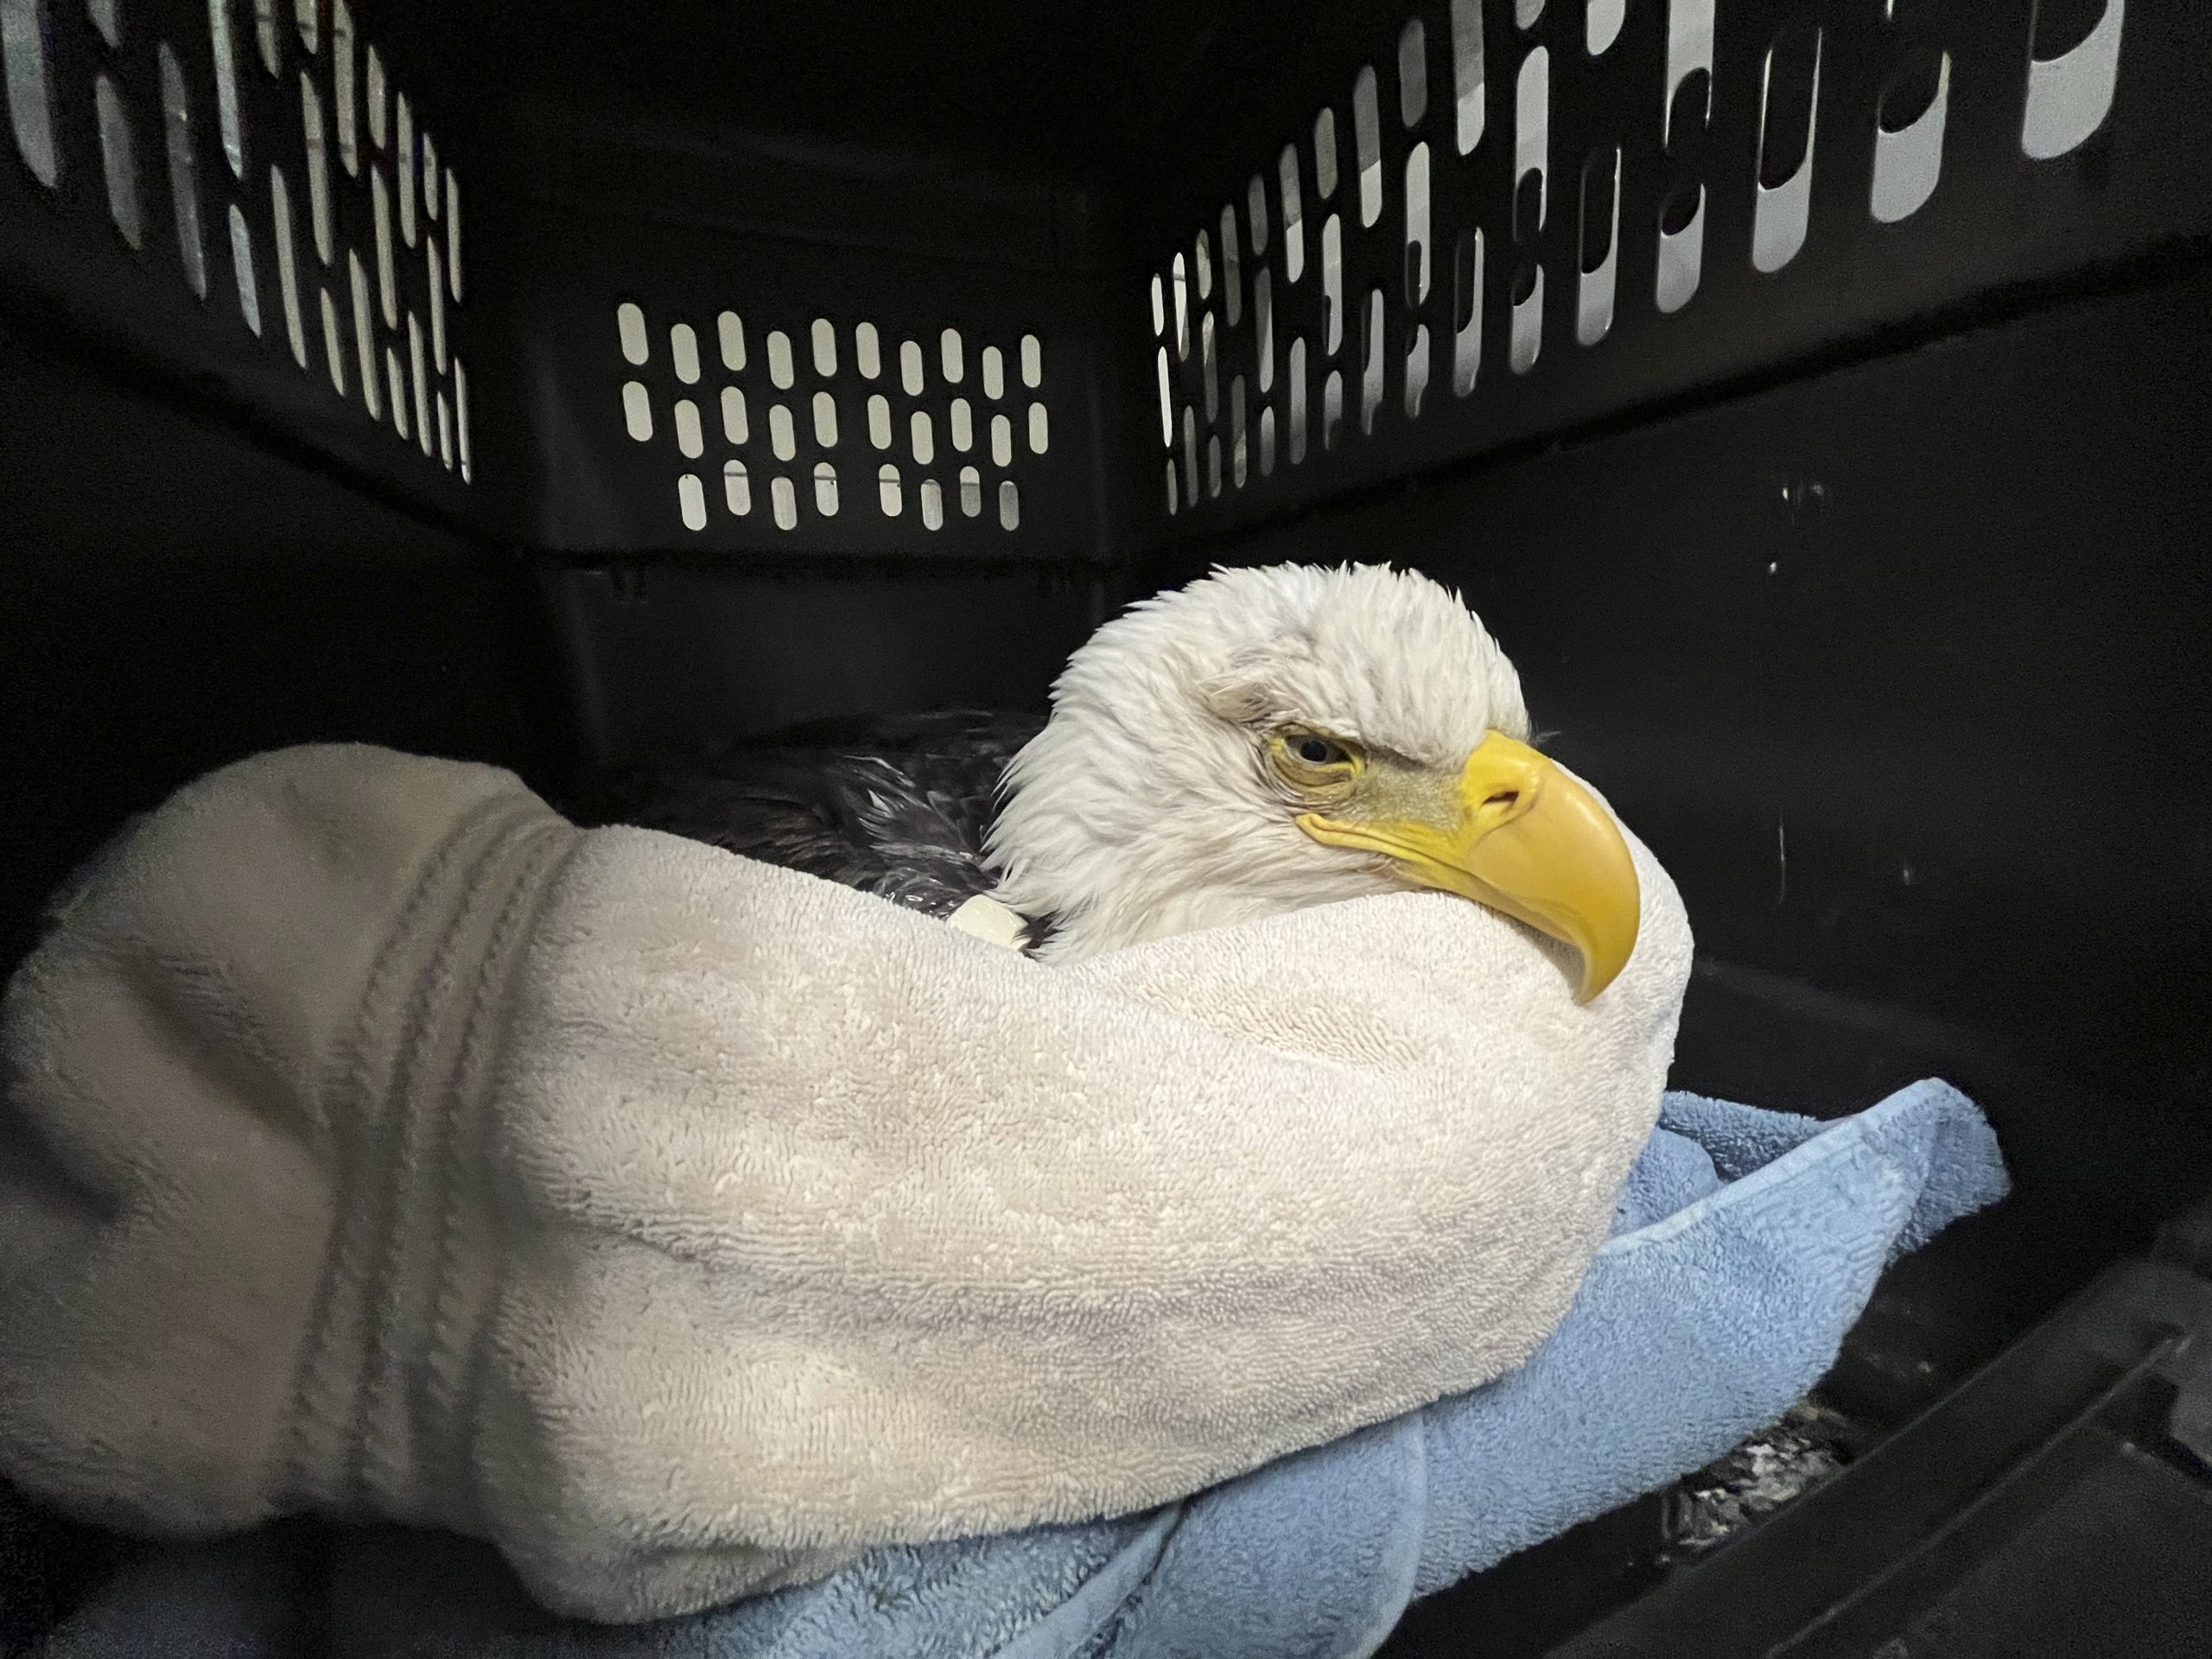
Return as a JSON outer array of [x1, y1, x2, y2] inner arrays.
[[597, 564, 1860, 1560]]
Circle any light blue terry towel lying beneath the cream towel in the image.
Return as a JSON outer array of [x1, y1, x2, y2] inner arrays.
[[35, 1082, 2006, 1659]]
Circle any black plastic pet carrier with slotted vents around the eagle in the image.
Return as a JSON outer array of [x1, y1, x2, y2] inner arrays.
[[0, 0, 2212, 1659]]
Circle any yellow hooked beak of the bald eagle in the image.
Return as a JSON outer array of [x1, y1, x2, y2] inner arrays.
[[1299, 732, 1642, 1002]]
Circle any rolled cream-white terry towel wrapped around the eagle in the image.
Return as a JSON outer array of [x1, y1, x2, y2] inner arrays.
[[0, 747, 1690, 1619]]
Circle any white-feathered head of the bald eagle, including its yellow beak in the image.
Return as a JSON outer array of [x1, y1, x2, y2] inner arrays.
[[988, 564, 1637, 998]]
